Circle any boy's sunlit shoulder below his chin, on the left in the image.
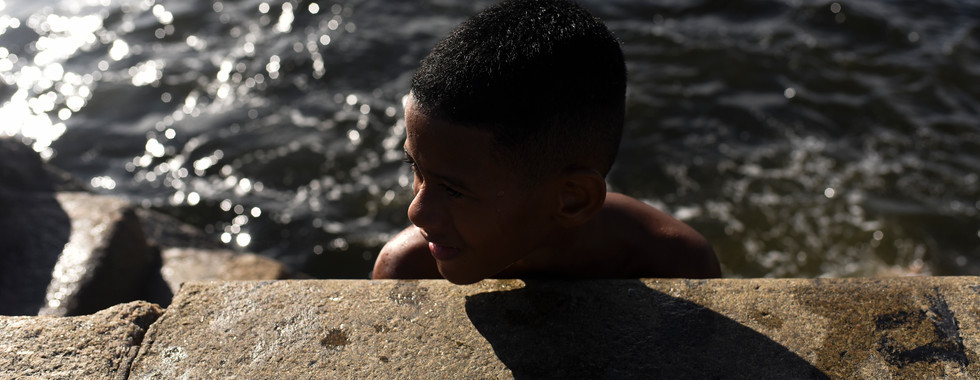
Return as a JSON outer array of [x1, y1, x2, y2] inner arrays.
[[371, 226, 442, 280]]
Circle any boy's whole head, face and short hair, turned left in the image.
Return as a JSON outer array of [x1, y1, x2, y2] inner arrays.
[[405, 0, 626, 283]]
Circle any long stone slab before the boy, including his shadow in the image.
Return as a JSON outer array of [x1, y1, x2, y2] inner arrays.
[[131, 277, 980, 379]]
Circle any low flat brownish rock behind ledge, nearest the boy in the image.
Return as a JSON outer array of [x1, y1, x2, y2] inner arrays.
[[160, 248, 289, 293]]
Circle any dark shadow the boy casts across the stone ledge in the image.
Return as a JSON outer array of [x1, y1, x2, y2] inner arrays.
[[466, 280, 827, 379]]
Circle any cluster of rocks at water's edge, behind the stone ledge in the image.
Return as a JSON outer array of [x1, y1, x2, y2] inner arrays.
[[0, 138, 293, 316]]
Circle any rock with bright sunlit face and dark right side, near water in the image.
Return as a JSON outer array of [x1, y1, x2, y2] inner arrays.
[[38, 193, 156, 315]]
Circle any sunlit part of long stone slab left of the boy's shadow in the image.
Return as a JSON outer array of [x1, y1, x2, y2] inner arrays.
[[131, 280, 506, 379]]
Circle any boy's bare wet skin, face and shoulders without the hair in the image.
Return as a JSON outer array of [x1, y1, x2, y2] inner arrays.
[[373, 100, 720, 284]]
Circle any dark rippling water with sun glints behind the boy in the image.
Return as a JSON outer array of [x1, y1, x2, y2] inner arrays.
[[0, 0, 980, 278]]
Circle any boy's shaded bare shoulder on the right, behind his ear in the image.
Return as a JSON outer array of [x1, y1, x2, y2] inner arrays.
[[603, 193, 721, 278]]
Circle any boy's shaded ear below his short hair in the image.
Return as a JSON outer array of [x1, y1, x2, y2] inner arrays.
[[555, 169, 606, 227]]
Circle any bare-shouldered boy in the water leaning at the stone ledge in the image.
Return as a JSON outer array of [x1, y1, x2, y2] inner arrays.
[[373, 0, 721, 284]]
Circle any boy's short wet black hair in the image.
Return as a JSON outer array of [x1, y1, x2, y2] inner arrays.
[[411, 0, 626, 180]]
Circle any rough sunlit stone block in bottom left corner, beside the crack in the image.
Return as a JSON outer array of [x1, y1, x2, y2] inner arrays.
[[0, 302, 163, 379]]
